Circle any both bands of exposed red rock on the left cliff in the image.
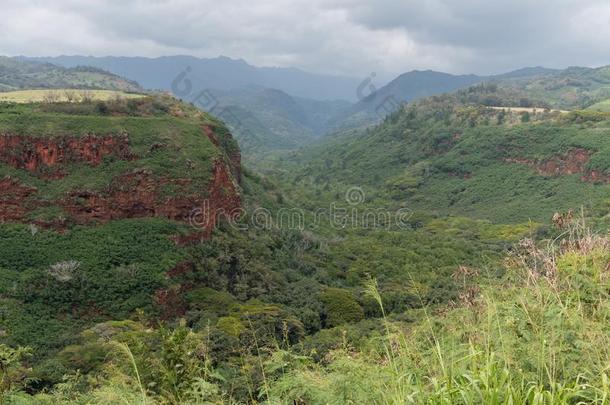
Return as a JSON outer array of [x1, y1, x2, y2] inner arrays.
[[0, 126, 241, 235]]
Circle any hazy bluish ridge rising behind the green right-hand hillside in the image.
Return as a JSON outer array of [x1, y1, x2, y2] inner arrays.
[[333, 67, 610, 129]]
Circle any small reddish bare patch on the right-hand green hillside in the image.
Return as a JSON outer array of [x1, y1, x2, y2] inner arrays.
[[504, 148, 610, 184]]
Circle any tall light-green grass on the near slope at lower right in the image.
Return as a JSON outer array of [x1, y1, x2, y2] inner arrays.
[[270, 219, 610, 404]]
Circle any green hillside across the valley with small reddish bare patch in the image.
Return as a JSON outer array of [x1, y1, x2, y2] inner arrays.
[[280, 85, 610, 222]]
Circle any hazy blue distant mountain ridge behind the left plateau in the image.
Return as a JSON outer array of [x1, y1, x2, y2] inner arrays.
[[20, 55, 360, 101]]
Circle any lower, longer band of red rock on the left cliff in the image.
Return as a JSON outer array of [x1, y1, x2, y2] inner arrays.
[[0, 160, 241, 234]]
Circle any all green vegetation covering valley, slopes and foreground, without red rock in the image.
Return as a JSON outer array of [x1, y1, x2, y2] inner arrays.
[[0, 68, 610, 404]]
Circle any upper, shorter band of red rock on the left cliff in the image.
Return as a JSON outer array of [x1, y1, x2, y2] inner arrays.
[[0, 134, 135, 177]]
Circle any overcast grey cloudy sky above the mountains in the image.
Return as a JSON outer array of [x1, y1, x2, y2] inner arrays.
[[0, 0, 610, 76]]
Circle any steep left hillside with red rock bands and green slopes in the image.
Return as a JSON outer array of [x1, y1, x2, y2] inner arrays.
[[0, 98, 241, 366]]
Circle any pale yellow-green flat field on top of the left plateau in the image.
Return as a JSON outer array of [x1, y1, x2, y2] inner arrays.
[[0, 89, 144, 103]]
